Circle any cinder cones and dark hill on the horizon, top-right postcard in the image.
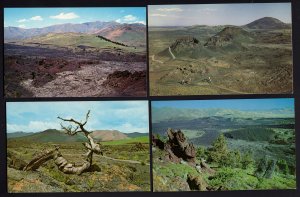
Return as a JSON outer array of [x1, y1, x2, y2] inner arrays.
[[158, 17, 291, 59]]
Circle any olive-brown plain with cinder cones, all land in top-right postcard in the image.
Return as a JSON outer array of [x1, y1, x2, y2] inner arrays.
[[148, 18, 293, 96]]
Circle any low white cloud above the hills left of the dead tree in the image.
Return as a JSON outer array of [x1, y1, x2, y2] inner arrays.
[[7, 121, 60, 132]]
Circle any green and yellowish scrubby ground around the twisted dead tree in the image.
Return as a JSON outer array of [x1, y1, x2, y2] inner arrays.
[[7, 136, 150, 193]]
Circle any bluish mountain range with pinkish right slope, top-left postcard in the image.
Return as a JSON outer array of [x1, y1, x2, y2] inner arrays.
[[4, 21, 146, 42]]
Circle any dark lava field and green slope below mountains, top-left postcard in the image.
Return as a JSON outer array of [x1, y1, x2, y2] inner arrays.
[[4, 22, 146, 97]]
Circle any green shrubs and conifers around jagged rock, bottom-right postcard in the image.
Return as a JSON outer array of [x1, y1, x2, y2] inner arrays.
[[153, 121, 296, 191]]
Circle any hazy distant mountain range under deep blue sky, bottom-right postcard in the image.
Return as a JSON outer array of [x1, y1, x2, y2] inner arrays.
[[152, 107, 295, 123]]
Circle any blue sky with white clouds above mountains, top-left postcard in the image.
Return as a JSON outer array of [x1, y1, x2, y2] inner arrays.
[[4, 7, 146, 28]]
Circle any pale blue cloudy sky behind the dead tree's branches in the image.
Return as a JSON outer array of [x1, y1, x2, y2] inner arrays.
[[6, 101, 149, 133]]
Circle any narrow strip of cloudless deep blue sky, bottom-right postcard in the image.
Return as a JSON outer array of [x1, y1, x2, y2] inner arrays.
[[151, 98, 294, 110]]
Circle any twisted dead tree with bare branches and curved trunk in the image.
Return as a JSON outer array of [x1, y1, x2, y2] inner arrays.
[[24, 110, 102, 174]]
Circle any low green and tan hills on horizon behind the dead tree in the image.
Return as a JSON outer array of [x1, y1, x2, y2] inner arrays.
[[7, 129, 148, 142]]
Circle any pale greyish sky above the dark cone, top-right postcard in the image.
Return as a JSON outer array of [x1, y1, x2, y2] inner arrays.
[[148, 3, 291, 26]]
